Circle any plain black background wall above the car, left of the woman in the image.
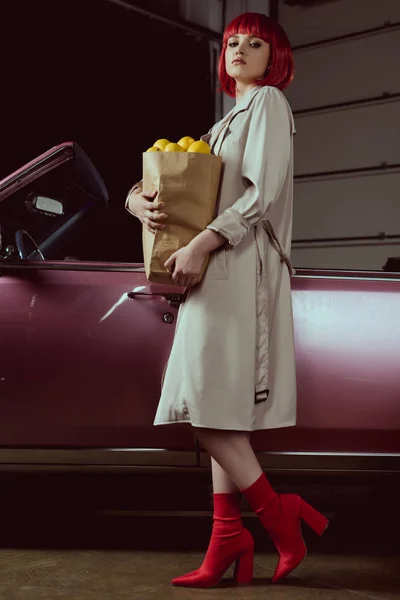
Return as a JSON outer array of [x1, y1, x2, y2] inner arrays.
[[0, 0, 214, 260]]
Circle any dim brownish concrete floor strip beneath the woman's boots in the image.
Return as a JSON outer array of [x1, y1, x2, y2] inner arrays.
[[0, 549, 400, 600]]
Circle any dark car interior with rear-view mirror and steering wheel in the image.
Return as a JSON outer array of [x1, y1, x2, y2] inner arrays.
[[0, 144, 108, 261]]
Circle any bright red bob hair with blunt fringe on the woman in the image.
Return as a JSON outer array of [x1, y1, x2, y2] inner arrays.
[[218, 13, 294, 97]]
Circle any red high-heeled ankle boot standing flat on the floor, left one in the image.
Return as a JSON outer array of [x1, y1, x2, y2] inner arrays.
[[172, 494, 254, 588]]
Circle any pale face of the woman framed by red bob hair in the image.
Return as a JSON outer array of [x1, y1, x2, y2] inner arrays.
[[225, 33, 270, 83]]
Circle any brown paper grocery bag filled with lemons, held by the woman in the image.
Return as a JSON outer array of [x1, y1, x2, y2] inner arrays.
[[143, 152, 222, 285]]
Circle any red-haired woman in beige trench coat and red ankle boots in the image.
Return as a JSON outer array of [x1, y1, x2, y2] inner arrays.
[[129, 13, 328, 587]]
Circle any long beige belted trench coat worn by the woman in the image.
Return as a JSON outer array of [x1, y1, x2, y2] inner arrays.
[[154, 86, 296, 431]]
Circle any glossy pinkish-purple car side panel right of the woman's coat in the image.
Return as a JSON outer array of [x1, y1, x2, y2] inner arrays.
[[253, 269, 400, 471]]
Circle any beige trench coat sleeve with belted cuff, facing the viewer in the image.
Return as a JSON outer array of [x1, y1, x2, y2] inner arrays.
[[208, 88, 292, 246]]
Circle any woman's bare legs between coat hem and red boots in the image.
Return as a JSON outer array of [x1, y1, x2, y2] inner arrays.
[[195, 427, 262, 493]]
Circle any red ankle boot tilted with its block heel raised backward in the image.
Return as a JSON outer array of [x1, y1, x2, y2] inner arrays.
[[243, 474, 329, 583]]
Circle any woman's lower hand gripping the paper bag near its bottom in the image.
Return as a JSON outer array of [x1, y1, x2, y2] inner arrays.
[[164, 244, 209, 287]]
